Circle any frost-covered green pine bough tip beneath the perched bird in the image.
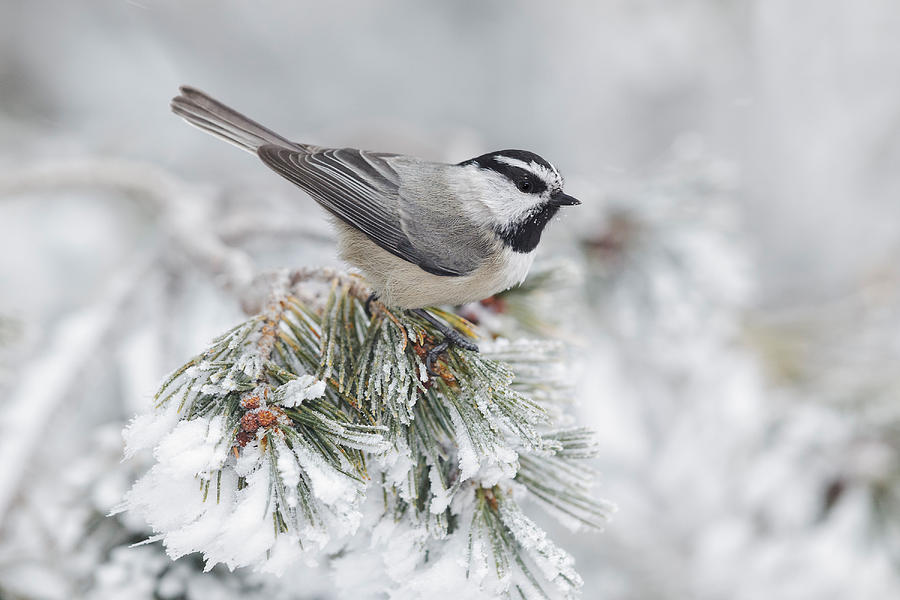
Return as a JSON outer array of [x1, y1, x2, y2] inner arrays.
[[122, 270, 611, 598]]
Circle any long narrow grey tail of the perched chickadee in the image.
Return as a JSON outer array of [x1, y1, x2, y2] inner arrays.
[[172, 86, 304, 154]]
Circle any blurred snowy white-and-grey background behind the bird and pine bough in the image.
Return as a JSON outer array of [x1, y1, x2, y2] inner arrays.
[[0, 0, 900, 600]]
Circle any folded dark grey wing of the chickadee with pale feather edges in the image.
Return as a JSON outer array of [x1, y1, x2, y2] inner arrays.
[[257, 145, 483, 276]]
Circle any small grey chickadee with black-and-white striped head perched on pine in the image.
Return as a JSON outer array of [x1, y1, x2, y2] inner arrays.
[[171, 86, 581, 372]]
